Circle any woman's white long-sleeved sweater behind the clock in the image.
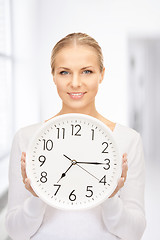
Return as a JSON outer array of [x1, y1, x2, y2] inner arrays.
[[6, 123, 146, 240]]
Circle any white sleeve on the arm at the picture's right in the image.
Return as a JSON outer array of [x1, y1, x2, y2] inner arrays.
[[102, 134, 146, 240]]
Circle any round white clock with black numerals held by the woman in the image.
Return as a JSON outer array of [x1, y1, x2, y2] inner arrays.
[[26, 114, 122, 210]]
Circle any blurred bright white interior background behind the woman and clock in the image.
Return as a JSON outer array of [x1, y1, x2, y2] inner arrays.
[[0, 0, 160, 240]]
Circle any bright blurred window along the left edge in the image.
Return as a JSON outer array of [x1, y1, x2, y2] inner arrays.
[[0, 0, 13, 160]]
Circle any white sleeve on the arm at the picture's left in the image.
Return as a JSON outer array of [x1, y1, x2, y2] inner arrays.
[[6, 130, 46, 240]]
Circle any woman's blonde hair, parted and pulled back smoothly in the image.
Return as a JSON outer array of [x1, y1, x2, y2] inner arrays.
[[51, 33, 103, 75]]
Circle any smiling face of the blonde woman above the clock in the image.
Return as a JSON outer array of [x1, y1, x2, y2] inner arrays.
[[53, 45, 104, 110]]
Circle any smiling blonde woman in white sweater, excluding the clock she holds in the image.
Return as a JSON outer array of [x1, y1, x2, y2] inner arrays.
[[6, 33, 145, 240]]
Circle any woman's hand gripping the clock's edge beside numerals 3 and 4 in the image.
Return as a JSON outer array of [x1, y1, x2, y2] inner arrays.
[[109, 153, 128, 198]]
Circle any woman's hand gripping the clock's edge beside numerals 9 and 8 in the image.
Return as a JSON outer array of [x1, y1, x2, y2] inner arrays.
[[21, 152, 38, 197]]
